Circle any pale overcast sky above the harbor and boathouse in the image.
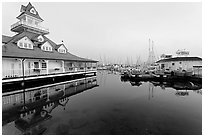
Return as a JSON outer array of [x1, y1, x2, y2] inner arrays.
[[2, 2, 202, 63]]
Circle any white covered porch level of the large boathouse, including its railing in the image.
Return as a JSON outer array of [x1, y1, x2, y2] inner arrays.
[[2, 59, 97, 80]]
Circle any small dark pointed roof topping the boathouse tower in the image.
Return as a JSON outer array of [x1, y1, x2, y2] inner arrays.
[[16, 2, 43, 21]]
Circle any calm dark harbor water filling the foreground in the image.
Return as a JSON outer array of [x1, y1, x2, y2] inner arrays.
[[2, 71, 202, 135]]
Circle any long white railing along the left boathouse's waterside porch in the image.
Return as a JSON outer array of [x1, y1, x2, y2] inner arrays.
[[2, 67, 96, 78]]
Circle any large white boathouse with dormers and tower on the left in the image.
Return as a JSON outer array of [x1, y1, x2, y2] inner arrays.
[[2, 3, 97, 91]]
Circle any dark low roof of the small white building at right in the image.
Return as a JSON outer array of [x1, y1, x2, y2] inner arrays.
[[156, 57, 202, 63]]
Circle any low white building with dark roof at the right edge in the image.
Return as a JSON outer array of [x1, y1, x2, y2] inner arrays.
[[156, 57, 202, 75]]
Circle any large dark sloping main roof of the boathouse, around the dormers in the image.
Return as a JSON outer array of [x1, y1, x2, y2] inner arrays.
[[2, 32, 97, 62]]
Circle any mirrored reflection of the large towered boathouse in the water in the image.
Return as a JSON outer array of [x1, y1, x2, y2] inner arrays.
[[2, 76, 98, 134]]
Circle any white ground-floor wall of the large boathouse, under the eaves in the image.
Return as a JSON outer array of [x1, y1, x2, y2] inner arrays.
[[2, 58, 96, 78]]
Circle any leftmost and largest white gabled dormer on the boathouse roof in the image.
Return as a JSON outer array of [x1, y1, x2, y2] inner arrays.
[[17, 37, 34, 49]]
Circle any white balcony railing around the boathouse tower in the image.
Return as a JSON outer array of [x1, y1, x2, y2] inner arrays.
[[11, 21, 49, 33]]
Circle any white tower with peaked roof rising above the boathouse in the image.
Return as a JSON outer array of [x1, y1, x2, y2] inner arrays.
[[11, 2, 49, 35]]
